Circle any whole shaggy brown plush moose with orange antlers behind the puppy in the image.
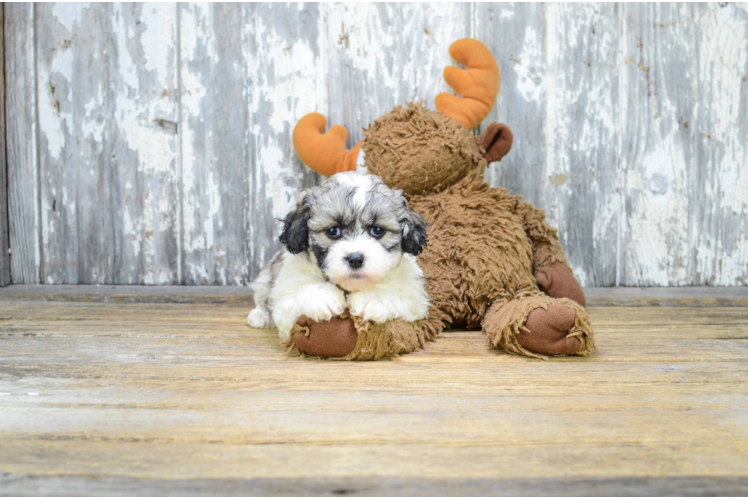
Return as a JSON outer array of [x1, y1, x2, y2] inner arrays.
[[287, 39, 594, 360]]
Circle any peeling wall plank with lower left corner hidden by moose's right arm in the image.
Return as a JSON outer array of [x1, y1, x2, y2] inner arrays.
[[539, 3, 621, 286]]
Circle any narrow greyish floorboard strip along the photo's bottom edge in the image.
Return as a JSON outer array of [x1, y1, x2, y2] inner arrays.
[[0, 474, 748, 498]]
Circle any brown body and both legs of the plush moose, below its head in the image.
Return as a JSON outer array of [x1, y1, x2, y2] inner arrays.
[[286, 173, 594, 361]]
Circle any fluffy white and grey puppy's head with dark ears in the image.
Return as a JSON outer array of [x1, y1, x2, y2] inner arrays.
[[280, 172, 426, 292]]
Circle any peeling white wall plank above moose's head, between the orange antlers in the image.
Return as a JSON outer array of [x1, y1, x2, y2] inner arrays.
[[325, 2, 472, 147]]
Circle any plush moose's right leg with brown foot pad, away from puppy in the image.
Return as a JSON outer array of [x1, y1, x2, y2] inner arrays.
[[483, 293, 595, 357]]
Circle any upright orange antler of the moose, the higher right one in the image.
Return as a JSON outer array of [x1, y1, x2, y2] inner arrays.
[[434, 38, 499, 129]]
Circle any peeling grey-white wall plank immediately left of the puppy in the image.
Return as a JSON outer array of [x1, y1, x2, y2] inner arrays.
[[179, 3, 250, 285]]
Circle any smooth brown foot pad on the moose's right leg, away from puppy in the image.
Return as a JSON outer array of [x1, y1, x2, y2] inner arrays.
[[517, 302, 582, 356]]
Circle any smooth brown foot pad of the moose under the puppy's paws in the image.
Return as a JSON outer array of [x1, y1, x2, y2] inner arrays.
[[294, 316, 358, 358]]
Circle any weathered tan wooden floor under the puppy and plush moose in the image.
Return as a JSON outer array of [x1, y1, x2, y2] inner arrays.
[[0, 291, 748, 495]]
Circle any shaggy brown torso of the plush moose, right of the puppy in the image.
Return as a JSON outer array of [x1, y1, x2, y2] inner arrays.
[[410, 177, 537, 328]]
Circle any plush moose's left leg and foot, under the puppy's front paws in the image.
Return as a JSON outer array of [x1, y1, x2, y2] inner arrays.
[[284, 310, 442, 361]]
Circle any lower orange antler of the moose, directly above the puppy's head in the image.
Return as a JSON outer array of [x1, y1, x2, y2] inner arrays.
[[293, 113, 364, 177]]
